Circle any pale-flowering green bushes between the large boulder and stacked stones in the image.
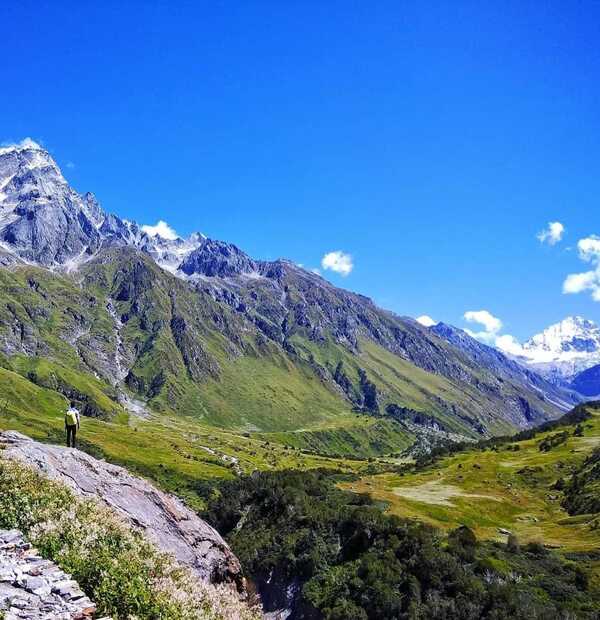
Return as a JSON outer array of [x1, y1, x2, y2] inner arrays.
[[0, 460, 258, 620]]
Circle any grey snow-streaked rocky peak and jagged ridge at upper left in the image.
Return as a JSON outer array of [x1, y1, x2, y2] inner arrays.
[[0, 138, 209, 277]]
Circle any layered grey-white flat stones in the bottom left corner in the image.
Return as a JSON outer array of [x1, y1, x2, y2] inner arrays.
[[0, 530, 96, 620]]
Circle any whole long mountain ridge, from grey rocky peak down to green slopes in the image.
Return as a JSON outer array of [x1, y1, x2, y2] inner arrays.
[[0, 141, 573, 444]]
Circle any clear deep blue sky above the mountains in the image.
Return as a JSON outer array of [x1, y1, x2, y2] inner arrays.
[[0, 1, 600, 339]]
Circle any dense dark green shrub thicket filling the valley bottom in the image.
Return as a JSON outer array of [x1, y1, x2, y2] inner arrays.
[[206, 470, 600, 620]]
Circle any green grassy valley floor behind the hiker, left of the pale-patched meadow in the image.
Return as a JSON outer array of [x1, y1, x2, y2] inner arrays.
[[0, 369, 374, 509]]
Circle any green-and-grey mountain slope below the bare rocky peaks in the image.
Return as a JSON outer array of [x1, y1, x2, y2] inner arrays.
[[0, 242, 576, 456]]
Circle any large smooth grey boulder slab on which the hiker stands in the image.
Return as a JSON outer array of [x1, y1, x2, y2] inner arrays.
[[0, 431, 243, 589]]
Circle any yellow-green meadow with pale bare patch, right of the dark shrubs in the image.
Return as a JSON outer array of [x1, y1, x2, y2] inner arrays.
[[340, 409, 600, 588]]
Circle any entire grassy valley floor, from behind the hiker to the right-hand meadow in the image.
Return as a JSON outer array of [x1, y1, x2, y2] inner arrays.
[[0, 360, 600, 612]]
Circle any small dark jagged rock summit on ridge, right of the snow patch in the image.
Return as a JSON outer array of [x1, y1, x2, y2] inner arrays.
[[179, 239, 257, 278]]
